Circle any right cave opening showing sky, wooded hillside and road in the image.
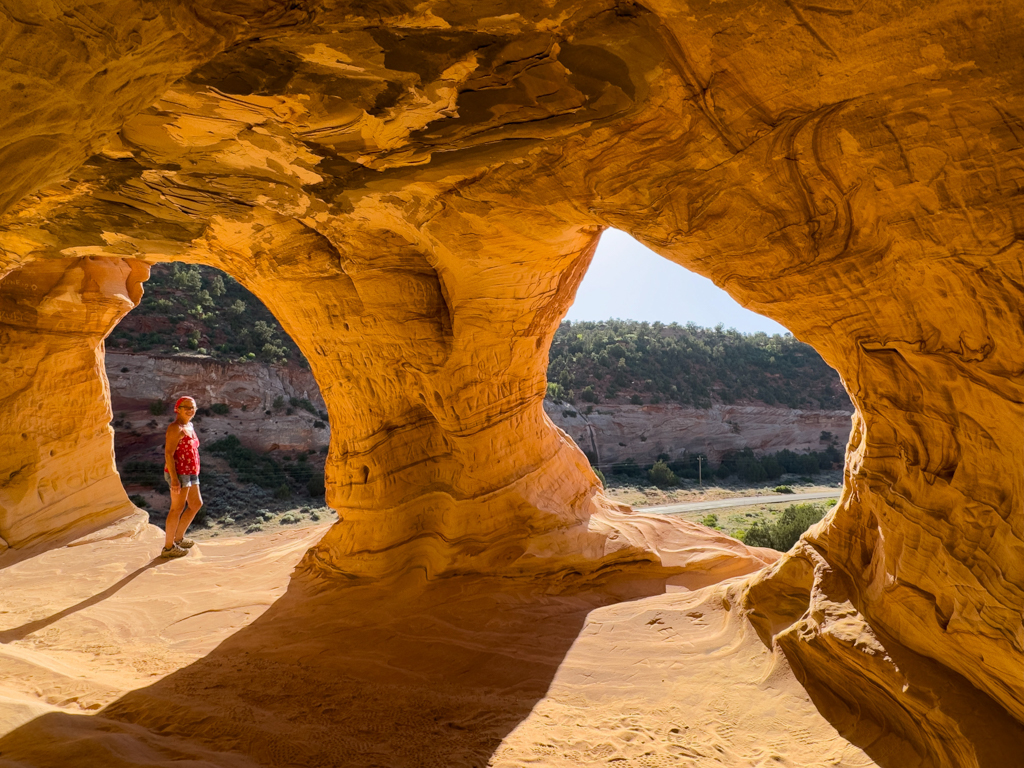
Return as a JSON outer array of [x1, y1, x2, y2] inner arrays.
[[545, 229, 853, 550]]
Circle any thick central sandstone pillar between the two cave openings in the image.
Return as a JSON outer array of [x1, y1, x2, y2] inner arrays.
[[196, 214, 634, 577]]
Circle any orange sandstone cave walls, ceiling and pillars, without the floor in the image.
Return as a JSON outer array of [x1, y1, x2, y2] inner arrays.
[[0, 0, 1024, 766]]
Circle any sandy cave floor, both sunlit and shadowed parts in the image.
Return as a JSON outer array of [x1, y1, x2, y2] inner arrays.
[[0, 524, 873, 768]]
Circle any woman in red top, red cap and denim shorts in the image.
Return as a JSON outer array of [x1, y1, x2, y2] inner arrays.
[[160, 397, 203, 557]]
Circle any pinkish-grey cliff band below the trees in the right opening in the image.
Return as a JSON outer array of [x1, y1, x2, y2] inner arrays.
[[544, 400, 853, 469]]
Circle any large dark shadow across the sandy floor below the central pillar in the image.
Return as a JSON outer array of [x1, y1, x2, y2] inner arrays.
[[0, 573, 664, 768]]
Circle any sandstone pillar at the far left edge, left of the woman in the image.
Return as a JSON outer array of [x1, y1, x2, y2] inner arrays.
[[0, 258, 148, 547]]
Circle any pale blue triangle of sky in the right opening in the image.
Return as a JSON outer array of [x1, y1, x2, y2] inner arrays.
[[565, 229, 787, 334]]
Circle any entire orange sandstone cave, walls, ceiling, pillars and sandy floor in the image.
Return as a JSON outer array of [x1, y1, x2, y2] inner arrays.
[[0, 0, 1024, 768]]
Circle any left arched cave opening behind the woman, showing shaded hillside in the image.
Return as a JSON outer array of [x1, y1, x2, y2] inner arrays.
[[105, 263, 334, 536]]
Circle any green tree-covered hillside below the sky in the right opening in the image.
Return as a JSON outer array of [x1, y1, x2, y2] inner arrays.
[[548, 319, 849, 410]]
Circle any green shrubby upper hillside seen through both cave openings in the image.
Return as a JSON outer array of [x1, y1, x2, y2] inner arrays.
[[109, 264, 849, 409]]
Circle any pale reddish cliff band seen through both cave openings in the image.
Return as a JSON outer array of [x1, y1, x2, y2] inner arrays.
[[106, 352, 853, 467]]
